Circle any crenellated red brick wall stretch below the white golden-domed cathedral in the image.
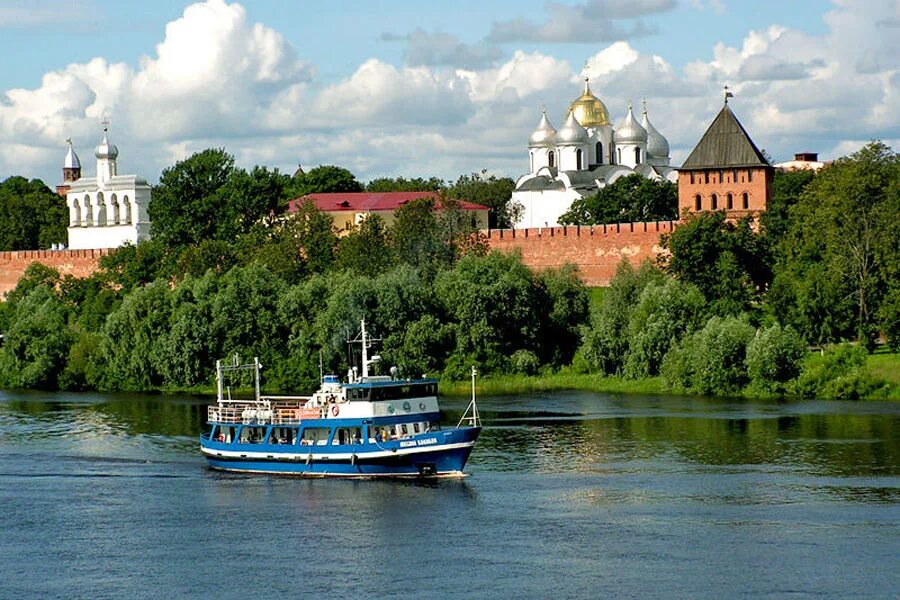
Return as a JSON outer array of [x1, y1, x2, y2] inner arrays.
[[485, 221, 677, 286]]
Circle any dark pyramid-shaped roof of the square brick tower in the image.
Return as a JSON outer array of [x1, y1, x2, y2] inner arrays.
[[681, 104, 772, 169]]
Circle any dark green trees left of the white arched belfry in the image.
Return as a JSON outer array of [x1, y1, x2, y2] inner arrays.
[[0, 177, 69, 250]]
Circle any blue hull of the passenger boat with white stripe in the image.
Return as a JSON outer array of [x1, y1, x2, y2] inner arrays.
[[200, 427, 481, 478]]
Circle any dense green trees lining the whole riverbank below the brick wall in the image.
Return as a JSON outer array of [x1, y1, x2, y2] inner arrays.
[[0, 142, 900, 398]]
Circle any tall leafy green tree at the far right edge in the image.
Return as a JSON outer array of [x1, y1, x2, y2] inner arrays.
[[773, 142, 900, 346]]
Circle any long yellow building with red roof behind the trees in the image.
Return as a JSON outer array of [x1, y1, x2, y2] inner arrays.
[[288, 192, 490, 232]]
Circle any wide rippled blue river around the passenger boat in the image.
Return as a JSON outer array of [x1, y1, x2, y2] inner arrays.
[[0, 392, 900, 599]]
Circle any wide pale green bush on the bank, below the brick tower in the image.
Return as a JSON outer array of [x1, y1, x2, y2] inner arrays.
[[661, 316, 755, 396]]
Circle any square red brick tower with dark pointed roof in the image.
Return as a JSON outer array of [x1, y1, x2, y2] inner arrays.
[[678, 94, 775, 219]]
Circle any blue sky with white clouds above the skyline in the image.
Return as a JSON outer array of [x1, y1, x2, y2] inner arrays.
[[0, 0, 900, 186]]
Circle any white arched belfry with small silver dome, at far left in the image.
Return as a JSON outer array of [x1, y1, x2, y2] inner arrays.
[[57, 123, 150, 250]]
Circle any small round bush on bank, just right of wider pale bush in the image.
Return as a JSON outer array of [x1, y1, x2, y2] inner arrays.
[[747, 323, 806, 395]]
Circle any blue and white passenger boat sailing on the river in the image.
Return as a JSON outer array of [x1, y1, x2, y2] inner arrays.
[[200, 321, 481, 478]]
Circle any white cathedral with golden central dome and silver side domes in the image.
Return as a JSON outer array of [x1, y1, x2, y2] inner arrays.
[[512, 77, 678, 227]]
